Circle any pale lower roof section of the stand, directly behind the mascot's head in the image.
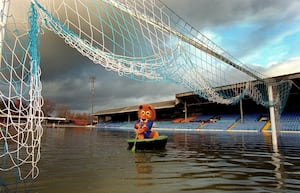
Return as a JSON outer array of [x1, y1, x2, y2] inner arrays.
[[93, 100, 175, 116]]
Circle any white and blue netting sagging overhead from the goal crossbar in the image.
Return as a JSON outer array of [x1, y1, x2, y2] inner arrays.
[[32, 0, 290, 107]]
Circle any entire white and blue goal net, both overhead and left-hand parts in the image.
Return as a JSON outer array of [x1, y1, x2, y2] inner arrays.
[[0, 0, 291, 178]]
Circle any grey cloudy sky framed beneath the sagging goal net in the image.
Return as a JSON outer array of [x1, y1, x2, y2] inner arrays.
[[40, 31, 184, 112]]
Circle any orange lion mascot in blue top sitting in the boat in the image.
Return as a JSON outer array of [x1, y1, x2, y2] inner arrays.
[[134, 104, 158, 139]]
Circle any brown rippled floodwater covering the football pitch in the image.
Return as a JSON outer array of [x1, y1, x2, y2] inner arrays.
[[0, 128, 300, 193]]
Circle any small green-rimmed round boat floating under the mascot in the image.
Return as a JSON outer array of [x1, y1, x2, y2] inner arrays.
[[127, 135, 168, 150]]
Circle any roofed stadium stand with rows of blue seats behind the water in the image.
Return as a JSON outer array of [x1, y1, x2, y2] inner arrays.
[[93, 73, 300, 132]]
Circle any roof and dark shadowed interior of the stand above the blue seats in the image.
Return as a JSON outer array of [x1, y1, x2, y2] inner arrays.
[[93, 73, 300, 122]]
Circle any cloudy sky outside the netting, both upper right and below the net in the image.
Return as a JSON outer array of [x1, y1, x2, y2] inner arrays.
[[9, 0, 300, 112]]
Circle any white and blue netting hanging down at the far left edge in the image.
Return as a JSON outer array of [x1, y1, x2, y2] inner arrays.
[[0, 1, 43, 179]]
